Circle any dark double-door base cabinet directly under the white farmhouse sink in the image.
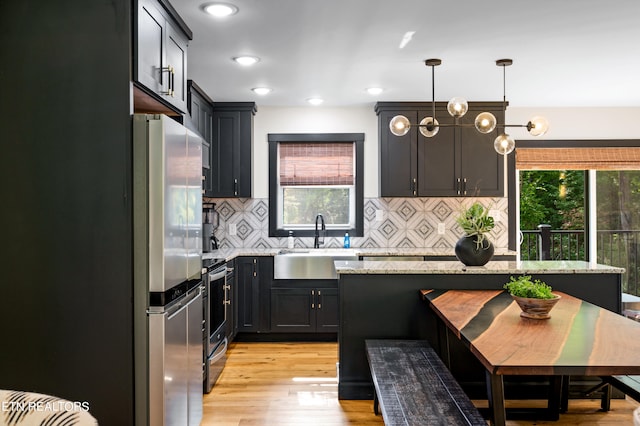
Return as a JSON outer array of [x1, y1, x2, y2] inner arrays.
[[271, 280, 339, 333]]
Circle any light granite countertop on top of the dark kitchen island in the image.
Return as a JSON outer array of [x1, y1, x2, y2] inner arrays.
[[335, 260, 624, 275]]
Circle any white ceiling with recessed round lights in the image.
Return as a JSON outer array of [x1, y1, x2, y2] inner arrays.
[[170, 0, 640, 107]]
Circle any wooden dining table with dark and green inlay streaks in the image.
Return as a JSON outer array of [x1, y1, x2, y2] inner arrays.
[[420, 290, 640, 425]]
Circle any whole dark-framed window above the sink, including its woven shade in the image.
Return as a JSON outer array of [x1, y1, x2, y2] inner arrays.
[[268, 133, 364, 237]]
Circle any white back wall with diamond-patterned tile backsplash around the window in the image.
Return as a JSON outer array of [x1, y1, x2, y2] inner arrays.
[[208, 103, 640, 248]]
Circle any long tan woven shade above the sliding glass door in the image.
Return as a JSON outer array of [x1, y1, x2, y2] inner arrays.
[[516, 147, 640, 170]]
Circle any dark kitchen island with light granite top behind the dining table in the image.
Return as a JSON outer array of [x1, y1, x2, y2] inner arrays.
[[335, 261, 624, 399]]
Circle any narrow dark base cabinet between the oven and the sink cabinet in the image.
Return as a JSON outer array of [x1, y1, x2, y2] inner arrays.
[[235, 256, 273, 333]]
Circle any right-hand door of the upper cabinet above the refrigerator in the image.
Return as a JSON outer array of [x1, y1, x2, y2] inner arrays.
[[165, 21, 188, 113]]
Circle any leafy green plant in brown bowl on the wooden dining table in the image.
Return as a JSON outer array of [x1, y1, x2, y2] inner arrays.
[[503, 275, 560, 319]]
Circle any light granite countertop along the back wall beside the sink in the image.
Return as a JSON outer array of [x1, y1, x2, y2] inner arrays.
[[202, 247, 516, 260]]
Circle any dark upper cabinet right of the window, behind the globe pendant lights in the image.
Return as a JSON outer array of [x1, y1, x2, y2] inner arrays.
[[376, 102, 504, 197]]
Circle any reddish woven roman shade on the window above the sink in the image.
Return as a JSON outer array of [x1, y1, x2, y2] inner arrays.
[[279, 142, 355, 186]]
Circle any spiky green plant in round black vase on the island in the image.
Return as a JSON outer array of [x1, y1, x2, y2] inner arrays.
[[455, 202, 495, 266]]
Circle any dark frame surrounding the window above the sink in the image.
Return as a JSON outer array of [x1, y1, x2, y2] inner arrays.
[[267, 133, 364, 237]]
